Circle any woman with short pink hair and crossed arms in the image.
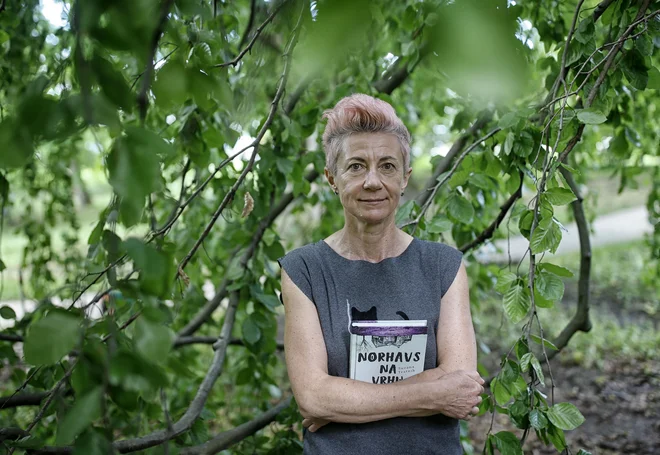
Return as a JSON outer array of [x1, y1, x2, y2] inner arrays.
[[280, 94, 484, 455]]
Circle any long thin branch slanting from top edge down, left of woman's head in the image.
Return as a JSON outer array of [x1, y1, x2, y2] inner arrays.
[[179, 4, 305, 270]]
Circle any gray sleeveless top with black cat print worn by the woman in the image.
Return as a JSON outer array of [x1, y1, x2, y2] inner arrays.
[[278, 239, 462, 455]]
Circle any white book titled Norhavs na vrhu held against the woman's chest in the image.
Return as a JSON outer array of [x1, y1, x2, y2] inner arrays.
[[349, 320, 428, 384]]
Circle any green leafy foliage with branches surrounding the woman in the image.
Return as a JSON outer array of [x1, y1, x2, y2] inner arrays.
[[0, 0, 660, 454]]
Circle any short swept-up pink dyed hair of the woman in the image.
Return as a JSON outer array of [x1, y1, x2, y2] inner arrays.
[[323, 93, 410, 174]]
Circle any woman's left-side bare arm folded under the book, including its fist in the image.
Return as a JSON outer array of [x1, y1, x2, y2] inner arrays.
[[282, 270, 483, 423]]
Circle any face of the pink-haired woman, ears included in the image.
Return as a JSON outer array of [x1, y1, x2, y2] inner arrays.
[[325, 133, 411, 224]]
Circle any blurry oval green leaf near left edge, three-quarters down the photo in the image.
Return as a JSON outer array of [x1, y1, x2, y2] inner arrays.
[[23, 310, 80, 365]]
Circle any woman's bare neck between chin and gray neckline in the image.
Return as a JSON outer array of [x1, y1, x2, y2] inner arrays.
[[326, 220, 412, 262]]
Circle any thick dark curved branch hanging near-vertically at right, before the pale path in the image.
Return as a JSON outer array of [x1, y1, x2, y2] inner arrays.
[[547, 166, 591, 360]]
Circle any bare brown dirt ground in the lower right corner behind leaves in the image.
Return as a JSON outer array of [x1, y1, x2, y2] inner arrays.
[[470, 359, 660, 455]]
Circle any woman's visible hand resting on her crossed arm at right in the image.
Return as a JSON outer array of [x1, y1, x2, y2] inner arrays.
[[427, 370, 485, 420]]
